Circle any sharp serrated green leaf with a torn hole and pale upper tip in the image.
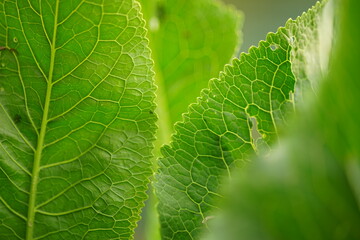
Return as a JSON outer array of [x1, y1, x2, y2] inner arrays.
[[156, 0, 332, 239]]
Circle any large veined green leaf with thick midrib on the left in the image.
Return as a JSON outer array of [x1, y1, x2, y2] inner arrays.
[[0, 0, 156, 240]]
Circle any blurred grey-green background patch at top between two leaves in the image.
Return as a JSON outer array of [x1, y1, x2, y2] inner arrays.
[[222, 0, 317, 52]]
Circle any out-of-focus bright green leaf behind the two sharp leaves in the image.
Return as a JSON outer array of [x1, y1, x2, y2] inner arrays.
[[140, 0, 242, 144]]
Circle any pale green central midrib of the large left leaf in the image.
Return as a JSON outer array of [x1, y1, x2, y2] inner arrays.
[[26, 0, 59, 240]]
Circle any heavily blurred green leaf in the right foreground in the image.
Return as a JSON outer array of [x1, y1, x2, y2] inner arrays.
[[204, 0, 360, 240]]
